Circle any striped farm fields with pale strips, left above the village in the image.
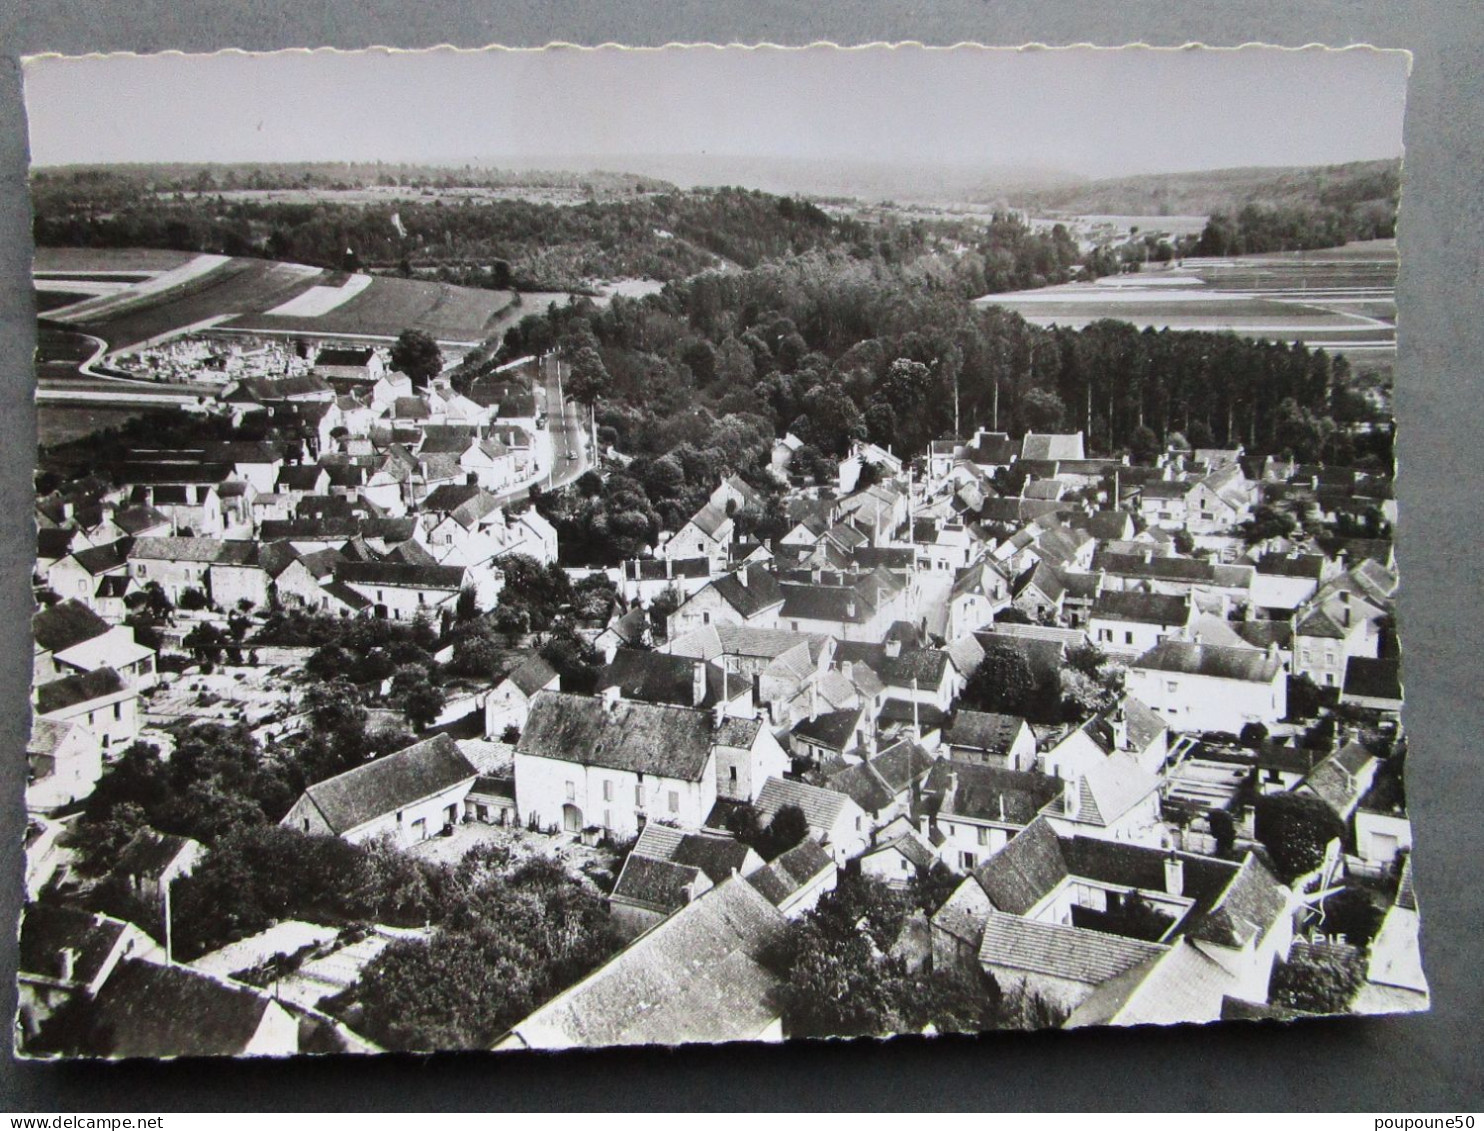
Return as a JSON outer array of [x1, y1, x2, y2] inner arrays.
[[37, 249, 512, 350]]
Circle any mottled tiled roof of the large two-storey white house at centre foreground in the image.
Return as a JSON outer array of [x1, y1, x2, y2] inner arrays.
[[516, 692, 712, 781]]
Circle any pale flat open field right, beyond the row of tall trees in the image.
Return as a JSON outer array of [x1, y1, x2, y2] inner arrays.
[[978, 240, 1396, 352]]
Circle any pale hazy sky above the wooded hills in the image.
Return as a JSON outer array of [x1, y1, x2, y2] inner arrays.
[[25, 46, 1408, 177]]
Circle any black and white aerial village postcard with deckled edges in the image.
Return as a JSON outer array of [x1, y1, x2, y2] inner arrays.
[[12, 45, 1424, 1058]]
